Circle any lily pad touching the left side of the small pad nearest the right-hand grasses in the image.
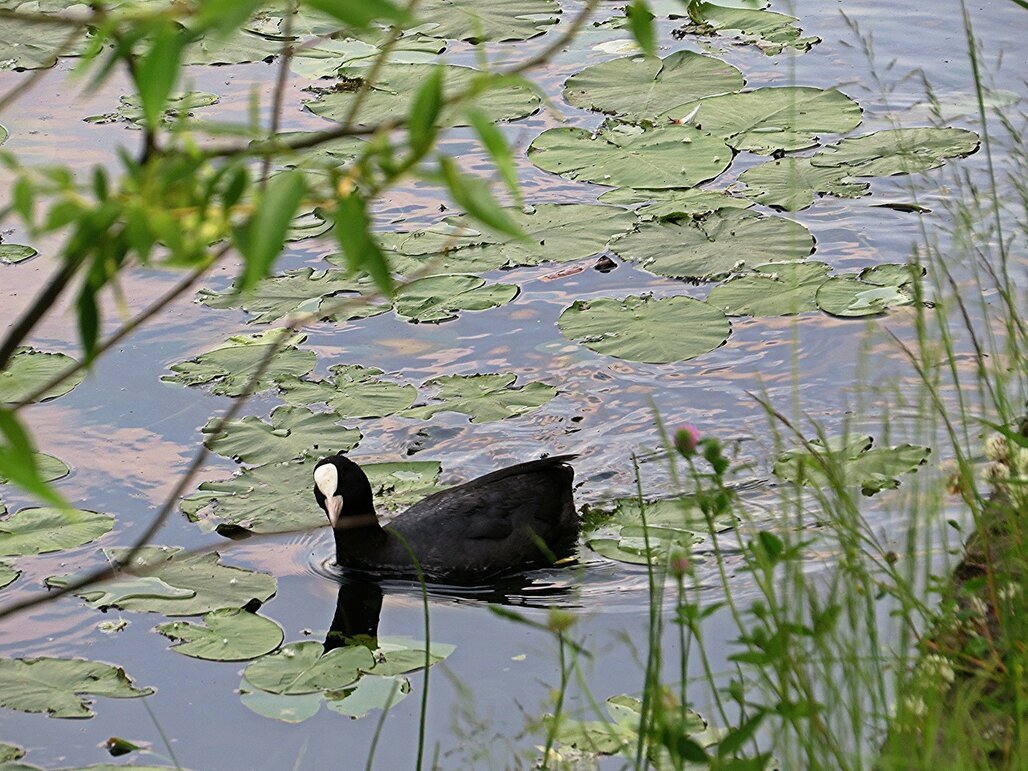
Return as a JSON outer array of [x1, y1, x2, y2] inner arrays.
[[707, 261, 830, 316]]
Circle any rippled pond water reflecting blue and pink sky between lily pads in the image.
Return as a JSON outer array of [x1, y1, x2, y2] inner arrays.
[[0, 0, 1024, 769]]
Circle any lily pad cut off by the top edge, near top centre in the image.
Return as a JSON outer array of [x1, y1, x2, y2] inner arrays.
[[415, 0, 560, 43]]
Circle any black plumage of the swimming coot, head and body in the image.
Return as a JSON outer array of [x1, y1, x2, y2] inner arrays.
[[315, 454, 579, 583]]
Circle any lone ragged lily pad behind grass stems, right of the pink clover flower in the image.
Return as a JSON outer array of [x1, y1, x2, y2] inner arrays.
[[773, 436, 931, 495]]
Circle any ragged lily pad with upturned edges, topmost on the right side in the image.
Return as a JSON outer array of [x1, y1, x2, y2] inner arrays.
[[674, 3, 821, 56]]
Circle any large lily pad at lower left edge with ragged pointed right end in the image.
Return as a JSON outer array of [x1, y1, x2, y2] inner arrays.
[[0, 657, 153, 718]]
